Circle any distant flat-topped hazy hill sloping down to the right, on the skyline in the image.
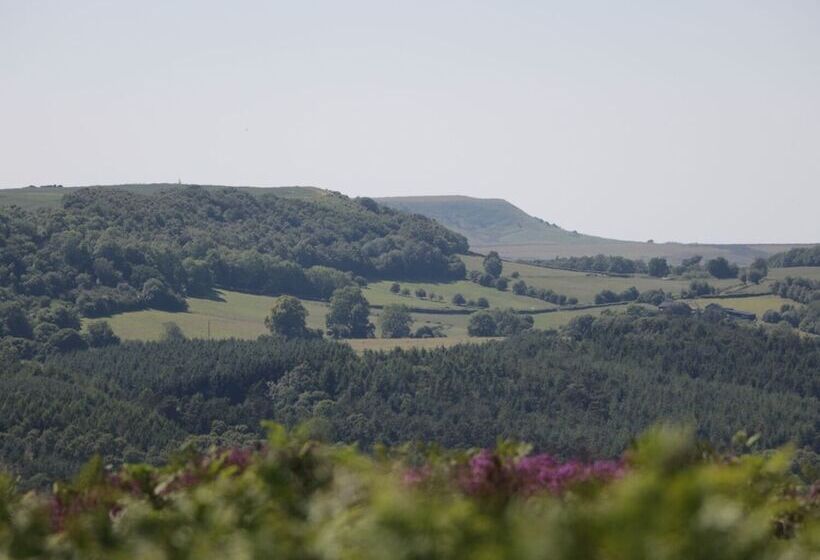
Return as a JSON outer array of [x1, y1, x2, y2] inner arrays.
[[377, 196, 812, 264]]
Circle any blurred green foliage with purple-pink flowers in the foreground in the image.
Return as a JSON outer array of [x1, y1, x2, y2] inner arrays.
[[0, 424, 820, 560]]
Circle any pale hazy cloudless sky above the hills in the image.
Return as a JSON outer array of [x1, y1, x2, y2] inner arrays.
[[0, 0, 820, 242]]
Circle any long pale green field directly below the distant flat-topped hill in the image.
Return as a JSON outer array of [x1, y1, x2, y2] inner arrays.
[[462, 256, 739, 304]]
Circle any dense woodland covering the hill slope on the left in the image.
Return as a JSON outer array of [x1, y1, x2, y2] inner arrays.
[[0, 187, 467, 358]]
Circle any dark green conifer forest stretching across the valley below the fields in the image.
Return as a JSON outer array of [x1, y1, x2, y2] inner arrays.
[[0, 316, 820, 486]]
